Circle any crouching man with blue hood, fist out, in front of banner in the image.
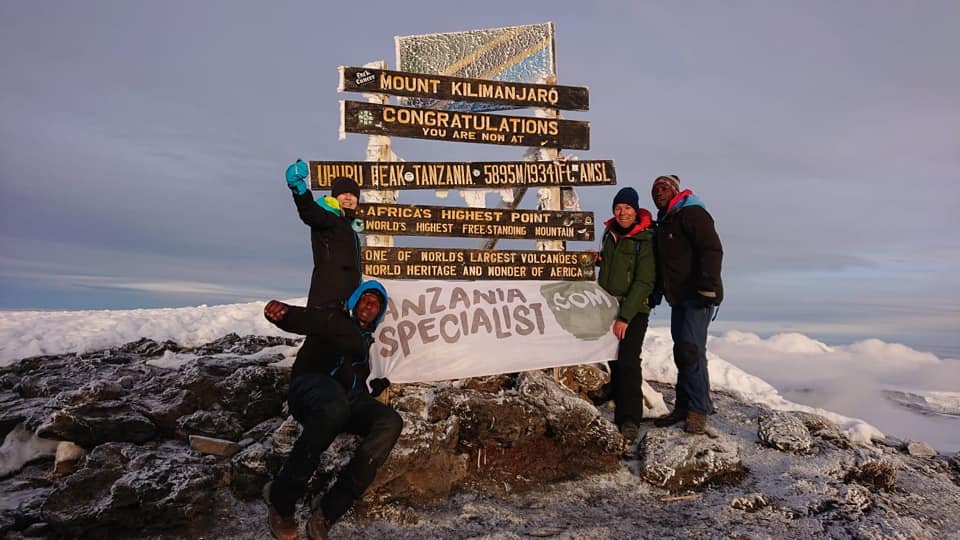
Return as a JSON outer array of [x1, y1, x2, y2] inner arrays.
[[263, 280, 403, 540]]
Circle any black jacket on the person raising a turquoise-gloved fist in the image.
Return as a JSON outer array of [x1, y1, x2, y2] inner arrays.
[[293, 191, 360, 307]]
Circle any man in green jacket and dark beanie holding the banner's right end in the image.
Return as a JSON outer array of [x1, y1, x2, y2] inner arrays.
[[597, 187, 655, 444]]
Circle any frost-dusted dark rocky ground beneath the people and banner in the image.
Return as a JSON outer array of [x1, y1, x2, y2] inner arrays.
[[0, 335, 960, 538]]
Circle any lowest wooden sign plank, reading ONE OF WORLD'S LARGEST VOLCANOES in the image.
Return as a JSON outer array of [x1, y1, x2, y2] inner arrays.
[[360, 246, 596, 281]]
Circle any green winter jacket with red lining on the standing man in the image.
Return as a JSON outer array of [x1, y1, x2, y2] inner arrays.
[[597, 209, 656, 323]]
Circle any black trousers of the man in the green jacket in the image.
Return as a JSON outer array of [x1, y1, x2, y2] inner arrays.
[[610, 313, 650, 426]]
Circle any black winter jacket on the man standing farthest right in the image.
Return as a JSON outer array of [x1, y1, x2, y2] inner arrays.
[[656, 193, 723, 306]]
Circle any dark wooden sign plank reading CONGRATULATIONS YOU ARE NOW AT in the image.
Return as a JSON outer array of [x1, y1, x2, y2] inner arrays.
[[340, 101, 590, 150]]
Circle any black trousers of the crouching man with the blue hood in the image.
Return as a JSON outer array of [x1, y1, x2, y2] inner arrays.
[[270, 373, 403, 523]]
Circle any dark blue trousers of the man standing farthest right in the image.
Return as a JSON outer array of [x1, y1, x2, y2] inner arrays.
[[670, 300, 714, 414]]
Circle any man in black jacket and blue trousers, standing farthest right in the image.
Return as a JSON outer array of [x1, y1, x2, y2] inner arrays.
[[650, 174, 723, 433]]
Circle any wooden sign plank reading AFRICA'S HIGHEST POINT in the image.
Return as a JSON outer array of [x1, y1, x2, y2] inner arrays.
[[357, 204, 594, 241]]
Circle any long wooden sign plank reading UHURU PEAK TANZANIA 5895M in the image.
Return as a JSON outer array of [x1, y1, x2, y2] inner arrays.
[[310, 160, 617, 190]]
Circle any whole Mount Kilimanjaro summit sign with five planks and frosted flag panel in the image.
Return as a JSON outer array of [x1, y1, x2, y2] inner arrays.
[[322, 23, 616, 281]]
